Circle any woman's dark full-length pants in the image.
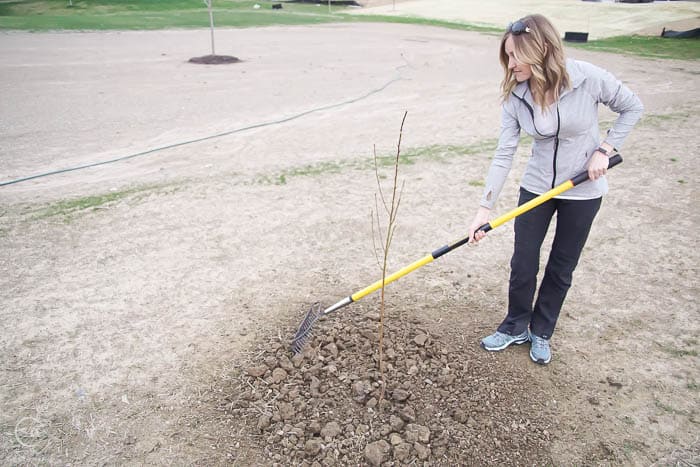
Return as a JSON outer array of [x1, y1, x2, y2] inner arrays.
[[498, 188, 601, 339]]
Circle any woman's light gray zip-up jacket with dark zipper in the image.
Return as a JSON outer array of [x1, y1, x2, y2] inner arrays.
[[480, 59, 644, 209]]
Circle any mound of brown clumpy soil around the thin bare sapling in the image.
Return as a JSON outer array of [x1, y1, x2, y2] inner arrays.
[[220, 313, 553, 466]]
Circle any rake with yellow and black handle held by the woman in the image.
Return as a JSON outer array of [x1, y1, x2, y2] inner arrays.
[[291, 154, 622, 355]]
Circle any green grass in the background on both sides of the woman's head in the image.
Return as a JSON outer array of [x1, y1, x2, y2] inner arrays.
[[0, 0, 700, 60]]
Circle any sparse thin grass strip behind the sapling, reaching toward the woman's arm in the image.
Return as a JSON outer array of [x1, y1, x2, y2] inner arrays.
[[253, 139, 496, 185]]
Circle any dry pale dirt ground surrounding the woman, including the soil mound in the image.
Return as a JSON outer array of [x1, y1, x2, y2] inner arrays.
[[0, 24, 700, 465]]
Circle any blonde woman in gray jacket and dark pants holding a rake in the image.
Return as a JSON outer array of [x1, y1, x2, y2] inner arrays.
[[470, 15, 643, 365]]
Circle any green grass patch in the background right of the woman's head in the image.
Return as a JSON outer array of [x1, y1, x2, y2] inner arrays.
[[570, 35, 700, 60]]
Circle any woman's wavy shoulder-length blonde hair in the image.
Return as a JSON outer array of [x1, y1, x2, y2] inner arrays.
[[499, 15, 571, 108]]
